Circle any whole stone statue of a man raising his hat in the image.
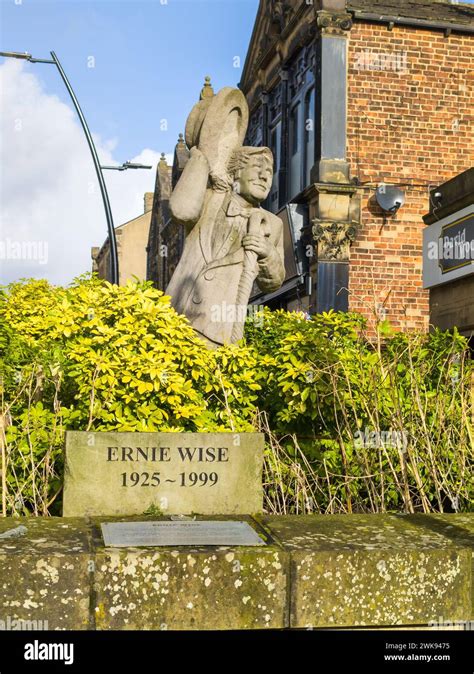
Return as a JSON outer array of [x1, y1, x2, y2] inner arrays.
[[166, 85, 285, 348]]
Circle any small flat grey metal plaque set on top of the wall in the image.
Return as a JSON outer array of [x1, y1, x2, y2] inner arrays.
[[101, 520, 265, 548]]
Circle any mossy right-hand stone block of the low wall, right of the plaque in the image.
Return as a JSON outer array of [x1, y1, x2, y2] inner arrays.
[[262, 515, 474, 628]]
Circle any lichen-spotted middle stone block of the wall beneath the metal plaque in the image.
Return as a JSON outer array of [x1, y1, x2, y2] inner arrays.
[[94, 518, 289, 630]]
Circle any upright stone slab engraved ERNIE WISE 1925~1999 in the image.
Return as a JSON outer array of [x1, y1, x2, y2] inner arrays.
[[63, 431, 264, 517]]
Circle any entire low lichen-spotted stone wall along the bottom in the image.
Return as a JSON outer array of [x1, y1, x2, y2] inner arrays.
[[0, 514, 474, 630]]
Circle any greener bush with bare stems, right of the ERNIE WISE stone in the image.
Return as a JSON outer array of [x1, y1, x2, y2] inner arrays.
[[247, 309, 474, 512]]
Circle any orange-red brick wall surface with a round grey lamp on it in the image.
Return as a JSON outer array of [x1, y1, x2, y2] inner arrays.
[[348, 22, 474, 330]]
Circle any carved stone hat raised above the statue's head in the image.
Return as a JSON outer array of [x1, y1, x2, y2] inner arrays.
[[186, 87, 249, 182]]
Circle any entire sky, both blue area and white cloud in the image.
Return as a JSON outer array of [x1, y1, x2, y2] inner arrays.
[[0, 0, 258, 285]]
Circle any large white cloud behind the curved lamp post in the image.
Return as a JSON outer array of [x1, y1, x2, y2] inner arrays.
[[0, 60, 168, 284]]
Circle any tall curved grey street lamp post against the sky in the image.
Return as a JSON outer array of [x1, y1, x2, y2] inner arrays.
[[0, 51, 152, 284]]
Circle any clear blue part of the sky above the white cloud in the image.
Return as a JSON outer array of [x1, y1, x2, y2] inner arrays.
[[1, 0, 258, 161]]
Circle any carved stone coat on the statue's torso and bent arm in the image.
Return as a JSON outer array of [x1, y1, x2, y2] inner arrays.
[[166, 189, 285, 344]]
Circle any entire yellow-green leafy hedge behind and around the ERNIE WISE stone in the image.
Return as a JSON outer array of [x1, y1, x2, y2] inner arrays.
[[0, 276, 473, 515]]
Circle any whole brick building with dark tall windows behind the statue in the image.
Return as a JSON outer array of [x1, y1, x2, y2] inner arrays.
[[148, 0, 474, 330]]
